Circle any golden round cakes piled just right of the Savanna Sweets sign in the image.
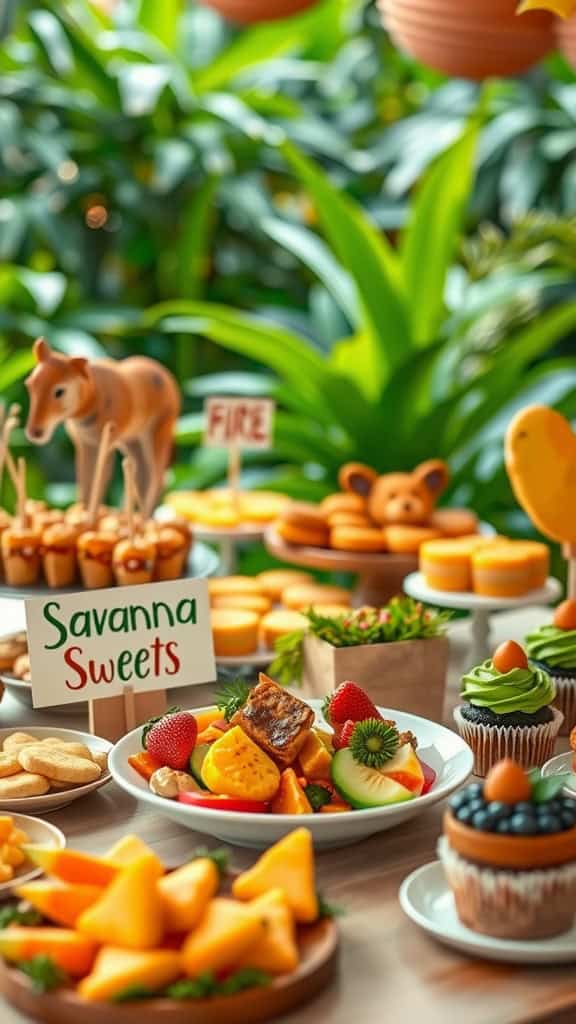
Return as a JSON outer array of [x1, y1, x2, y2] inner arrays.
[[208, 569, 351, 657]]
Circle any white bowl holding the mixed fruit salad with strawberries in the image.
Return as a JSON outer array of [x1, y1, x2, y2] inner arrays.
[[109, 700, 474, 849]]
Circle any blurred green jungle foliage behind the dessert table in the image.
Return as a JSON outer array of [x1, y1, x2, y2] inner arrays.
[[0, 0, 576, 552]]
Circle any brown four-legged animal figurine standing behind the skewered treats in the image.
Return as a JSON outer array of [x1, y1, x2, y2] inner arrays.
[[26, 338, 180, 516]]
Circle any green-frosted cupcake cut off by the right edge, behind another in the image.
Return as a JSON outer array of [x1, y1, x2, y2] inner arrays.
[[526, 598, 576, 736]]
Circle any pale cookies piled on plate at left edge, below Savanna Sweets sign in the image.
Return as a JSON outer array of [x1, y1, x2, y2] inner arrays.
[[0, 732, 108, 801]]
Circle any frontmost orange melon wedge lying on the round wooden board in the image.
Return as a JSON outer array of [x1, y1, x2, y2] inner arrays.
[[77, 946, 181, 999]]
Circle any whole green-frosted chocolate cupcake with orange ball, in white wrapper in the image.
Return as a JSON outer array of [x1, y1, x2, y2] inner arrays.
[[454, 640, 564, 775]]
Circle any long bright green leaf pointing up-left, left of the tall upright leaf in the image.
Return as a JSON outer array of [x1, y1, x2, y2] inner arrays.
[[282, 142, 412, 399]]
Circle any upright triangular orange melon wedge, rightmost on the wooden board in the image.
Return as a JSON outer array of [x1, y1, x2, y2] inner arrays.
[[233, 828, 318, 924]]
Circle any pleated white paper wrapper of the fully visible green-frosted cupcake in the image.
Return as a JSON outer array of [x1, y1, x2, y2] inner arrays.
[[454, 708, 564, 776]]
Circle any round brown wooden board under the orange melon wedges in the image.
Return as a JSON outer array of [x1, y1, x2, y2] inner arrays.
[[0, 918, 338, 1024]]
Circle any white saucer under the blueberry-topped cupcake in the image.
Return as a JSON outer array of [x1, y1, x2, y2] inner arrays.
[[399, 860, 576, 964]]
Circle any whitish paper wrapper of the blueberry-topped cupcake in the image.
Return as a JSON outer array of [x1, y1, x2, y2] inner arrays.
[[438, 836, 576, 939]]
